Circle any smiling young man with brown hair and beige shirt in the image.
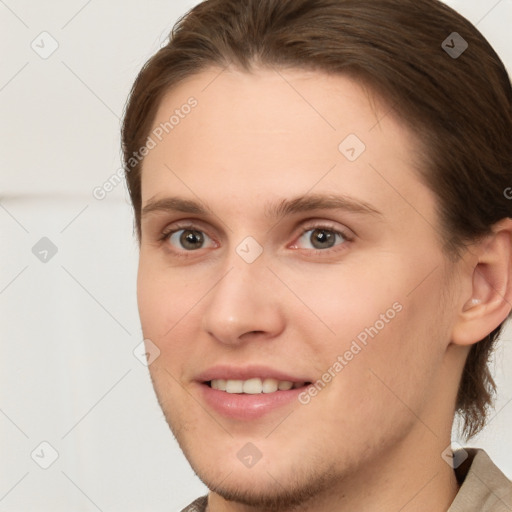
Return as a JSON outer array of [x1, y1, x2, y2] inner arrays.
[[123, 0, 512, 512]]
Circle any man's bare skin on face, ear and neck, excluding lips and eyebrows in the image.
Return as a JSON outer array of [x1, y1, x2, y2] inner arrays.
[[138, 68, 511, 512]]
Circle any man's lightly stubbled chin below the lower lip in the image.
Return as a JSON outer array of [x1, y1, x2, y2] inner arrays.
[[177, 430, 341, 512]]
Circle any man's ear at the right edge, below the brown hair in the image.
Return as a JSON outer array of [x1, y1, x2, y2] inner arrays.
[[451, 218, 512, 345]]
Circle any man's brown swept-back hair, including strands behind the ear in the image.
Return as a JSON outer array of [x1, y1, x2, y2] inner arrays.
[[122, 0, 512, 438]]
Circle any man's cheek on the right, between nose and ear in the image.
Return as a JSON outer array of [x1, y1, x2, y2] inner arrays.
[[289, 256, 448, 396]]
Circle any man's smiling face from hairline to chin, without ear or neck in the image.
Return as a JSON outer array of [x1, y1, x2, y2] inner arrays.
[[138, 69, 460, 504]]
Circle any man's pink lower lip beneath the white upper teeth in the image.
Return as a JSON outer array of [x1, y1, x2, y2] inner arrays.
[[199, 383, 307, 420]]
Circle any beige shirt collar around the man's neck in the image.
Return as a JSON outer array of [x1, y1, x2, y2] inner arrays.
[[181, 448, 512, 512]]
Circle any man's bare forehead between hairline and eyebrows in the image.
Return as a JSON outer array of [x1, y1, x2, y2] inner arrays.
[[142, 64, 432, 224]]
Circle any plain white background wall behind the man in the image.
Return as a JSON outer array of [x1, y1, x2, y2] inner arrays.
[[0, 0, 512, 512]]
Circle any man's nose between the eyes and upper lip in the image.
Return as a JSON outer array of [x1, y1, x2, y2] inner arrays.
[[202, 256, 285, 345]]
